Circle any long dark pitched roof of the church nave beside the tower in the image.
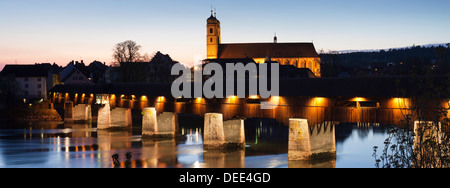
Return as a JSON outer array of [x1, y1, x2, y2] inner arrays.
[[219, 43, 319, 59]]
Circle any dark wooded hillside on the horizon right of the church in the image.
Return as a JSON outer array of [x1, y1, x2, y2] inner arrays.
[[320, 44, 450, 77]]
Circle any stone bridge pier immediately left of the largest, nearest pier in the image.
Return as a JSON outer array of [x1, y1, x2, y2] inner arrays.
[[203, 113, 245, 149]]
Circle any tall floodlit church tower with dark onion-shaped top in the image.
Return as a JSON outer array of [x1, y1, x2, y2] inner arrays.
[[206, 10, 220, 59]]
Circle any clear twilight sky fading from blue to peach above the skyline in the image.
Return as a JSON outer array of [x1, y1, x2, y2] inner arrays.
[[0, 0, 450, 68]]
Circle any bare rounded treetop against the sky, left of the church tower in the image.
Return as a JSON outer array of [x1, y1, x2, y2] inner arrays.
[[113, 40, 141, 64]]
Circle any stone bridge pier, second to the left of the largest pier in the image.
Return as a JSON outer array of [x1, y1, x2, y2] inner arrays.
[[142, 108, 178, 138]]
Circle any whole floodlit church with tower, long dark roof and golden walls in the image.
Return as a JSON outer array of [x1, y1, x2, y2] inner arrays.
[[206, 11, 321, 77]]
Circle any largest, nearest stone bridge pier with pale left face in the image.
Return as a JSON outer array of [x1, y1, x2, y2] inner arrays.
[[288, 118, 336, 161]]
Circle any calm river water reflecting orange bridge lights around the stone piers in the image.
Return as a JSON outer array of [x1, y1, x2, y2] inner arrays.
[[0, 119, 390, 168]]
